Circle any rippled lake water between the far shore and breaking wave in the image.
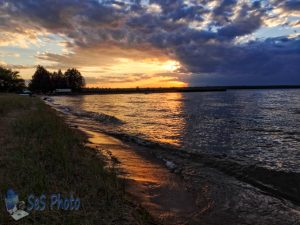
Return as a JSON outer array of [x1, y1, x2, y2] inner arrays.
[[53, 90, 300, 172]]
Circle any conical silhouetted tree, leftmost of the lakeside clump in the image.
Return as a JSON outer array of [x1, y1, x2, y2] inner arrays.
[[29, 66, 53, 93]]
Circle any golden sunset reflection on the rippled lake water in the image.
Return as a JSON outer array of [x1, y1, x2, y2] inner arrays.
[[53, 93, 186, 146]]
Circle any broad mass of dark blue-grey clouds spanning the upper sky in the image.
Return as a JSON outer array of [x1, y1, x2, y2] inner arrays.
[[0, 0, 300, 85]]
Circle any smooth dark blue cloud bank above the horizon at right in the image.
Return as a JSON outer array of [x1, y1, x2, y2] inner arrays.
[[185, 38, 300, 85]]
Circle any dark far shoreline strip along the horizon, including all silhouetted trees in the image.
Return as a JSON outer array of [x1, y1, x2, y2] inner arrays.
[[0, 65, 300, 95]]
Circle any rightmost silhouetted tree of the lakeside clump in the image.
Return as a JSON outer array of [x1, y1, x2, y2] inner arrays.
[[64, 68, 85, 91]]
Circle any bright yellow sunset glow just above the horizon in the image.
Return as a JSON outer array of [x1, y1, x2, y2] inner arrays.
[[82, 58, 187, 88]]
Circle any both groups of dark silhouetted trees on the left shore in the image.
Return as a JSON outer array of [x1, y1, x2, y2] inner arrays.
[[0, 66, 85, 93]]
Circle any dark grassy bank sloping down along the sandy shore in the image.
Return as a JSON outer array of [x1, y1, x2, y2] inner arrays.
[[0, 94, 154, 225]]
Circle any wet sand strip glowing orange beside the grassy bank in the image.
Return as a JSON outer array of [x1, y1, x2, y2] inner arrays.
[[82, 128, 201, 224]]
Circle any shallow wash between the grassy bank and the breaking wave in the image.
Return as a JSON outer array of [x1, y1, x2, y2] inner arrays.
[[48, 108, 300, 225]]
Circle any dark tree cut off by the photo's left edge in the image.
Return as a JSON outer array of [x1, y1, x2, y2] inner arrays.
[[0, 67, 25, 91]]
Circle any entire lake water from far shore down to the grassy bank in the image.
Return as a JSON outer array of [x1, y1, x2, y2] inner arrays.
[[45, 90, 300, 225]]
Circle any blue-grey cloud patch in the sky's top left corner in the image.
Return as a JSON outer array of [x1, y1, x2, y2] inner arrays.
[[3, 0, 118, 29]]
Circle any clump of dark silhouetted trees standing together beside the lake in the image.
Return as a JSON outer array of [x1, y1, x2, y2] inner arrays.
[[29, 66, 85, 93]]
